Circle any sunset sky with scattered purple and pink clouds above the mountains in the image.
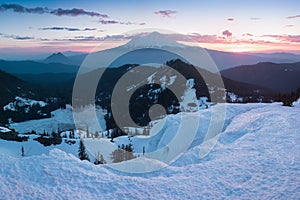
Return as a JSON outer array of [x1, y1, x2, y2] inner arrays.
[[0, 0, 300, 57]]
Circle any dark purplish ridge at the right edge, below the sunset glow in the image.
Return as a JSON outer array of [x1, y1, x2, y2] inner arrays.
[[221, 62, 300, 93]]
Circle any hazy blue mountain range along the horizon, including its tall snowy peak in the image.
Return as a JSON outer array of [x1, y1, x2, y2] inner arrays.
[[0, 32, 300, 74]]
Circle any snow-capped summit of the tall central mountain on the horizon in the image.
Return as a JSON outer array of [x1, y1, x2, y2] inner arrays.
[[124, 32, 184, 48]]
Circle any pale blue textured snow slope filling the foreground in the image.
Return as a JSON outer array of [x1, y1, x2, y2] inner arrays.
[[0, 102, 300, 199]]
